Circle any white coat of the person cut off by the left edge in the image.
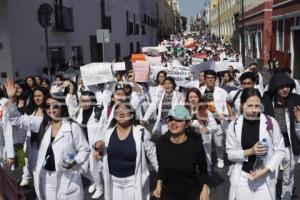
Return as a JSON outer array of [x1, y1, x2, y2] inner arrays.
[[0, 98, 15, 162]]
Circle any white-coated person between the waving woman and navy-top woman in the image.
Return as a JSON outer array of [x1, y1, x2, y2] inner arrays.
[[76, 91, 103, 199]]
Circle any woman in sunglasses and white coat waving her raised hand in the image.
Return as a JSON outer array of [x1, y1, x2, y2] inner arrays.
[[6, 79, 89, 200]]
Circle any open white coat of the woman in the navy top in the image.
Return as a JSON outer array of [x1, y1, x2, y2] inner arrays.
[[102, 126, 158, 200]]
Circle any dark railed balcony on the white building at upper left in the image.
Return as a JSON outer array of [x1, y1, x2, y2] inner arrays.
[[54, 5, 74, 32]]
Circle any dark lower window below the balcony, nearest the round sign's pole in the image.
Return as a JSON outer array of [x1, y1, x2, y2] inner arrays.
[[49, 47, 66, 71]]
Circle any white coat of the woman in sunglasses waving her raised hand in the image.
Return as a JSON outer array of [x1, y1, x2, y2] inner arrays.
[[9, 106, 90, 200]]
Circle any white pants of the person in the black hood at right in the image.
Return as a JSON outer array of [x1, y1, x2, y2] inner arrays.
[[281, 147, 297, 200]]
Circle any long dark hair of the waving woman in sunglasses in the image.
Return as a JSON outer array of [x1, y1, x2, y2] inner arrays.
[[36, 95, 72, 148]]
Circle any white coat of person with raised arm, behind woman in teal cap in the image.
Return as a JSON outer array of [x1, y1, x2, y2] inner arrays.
[[143, 91, 184, 133]]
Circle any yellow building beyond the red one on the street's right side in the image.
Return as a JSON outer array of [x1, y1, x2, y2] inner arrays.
[[210, 0, 240, 43]]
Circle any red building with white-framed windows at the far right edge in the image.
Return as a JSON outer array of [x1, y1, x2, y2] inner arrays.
[[271, 0, 300, 79]]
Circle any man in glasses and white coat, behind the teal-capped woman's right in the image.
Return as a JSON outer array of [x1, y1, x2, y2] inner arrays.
[[200, 70, 228, 168]]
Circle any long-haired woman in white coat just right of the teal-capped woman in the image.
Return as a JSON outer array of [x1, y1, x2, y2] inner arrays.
[[185, 88, 218, 175]]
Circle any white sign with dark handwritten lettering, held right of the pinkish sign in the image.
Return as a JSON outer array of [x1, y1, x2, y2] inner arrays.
[[168, 64, 190, 86]]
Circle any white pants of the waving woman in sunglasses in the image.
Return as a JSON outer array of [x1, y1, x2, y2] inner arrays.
[[41, 169, 57, 200]]
